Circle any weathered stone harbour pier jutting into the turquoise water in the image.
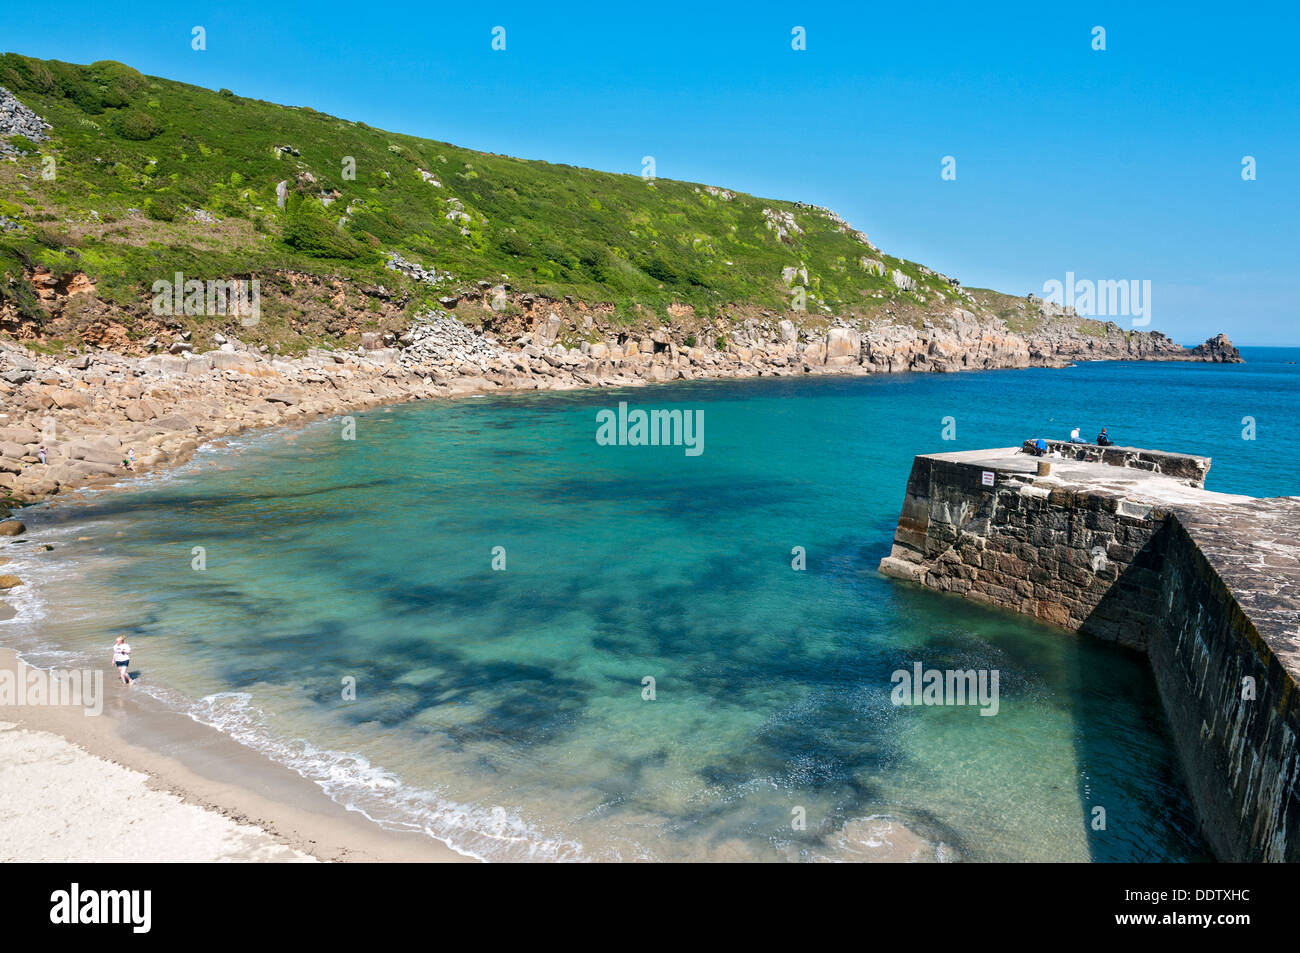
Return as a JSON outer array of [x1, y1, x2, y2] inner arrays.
[[880, 442, 1300, 861]]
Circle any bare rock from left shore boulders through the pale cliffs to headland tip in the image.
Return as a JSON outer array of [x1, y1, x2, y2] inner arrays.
[[0, 295, 1239, 502]]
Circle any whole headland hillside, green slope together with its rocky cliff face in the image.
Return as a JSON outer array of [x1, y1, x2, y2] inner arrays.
[[0, 53, 1235, 373]]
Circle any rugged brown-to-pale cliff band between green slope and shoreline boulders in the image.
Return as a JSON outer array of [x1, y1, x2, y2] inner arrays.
[[0, 263, 1242, 380]]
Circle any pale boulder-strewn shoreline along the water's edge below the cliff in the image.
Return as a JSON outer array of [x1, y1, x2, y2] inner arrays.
[[0, 315, 1240, 509]]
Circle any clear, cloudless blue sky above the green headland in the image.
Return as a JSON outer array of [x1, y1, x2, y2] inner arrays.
[[0, 0, 1300, 345]]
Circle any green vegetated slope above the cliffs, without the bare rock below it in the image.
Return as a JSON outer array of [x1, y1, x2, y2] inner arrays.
[[0, 53, 993, 338]]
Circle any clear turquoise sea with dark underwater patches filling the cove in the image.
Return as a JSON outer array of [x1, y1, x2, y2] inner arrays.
[[0, 348, 1300, 861]]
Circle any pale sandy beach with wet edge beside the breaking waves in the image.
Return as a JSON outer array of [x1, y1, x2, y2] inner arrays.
[[0, 650, 471, 863]]
